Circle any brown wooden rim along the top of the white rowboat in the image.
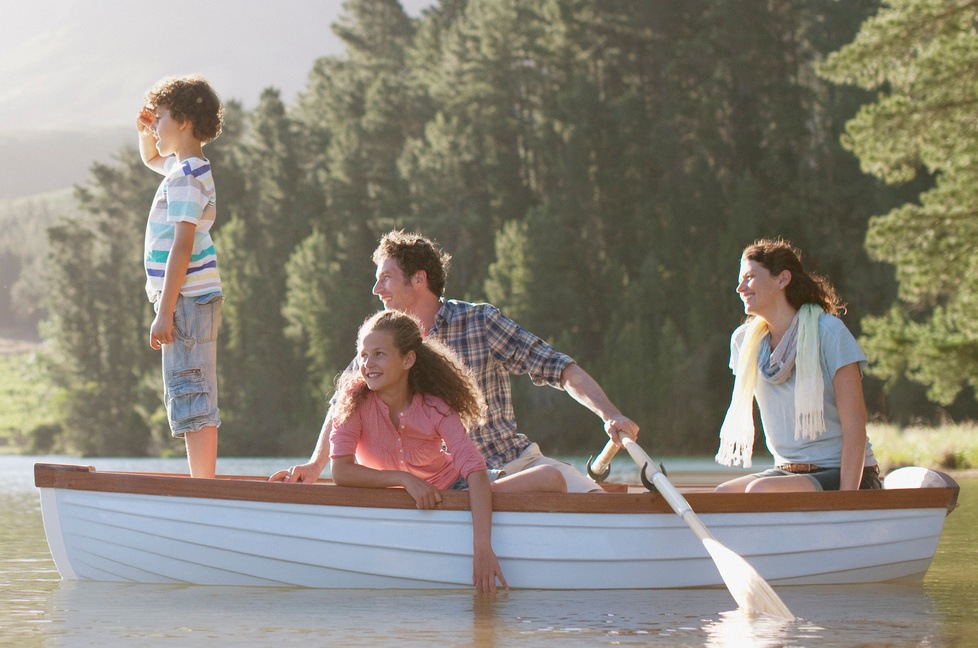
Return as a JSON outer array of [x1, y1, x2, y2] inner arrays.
[[34, 463, 959, 514]]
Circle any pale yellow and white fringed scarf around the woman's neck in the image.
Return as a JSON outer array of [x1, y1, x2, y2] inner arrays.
[[716, 304, 825, 468]]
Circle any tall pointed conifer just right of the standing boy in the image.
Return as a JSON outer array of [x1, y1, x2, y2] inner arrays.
[[216, 89, 319, 455]]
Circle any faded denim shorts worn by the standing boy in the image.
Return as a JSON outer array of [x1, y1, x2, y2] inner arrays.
[[154, 293, 224, 437]]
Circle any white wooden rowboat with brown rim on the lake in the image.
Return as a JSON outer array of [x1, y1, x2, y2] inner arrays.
[[34, 463, 958, 589]]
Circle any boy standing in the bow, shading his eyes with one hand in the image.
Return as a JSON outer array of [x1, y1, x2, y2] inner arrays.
[[136, 76, 224, 477]]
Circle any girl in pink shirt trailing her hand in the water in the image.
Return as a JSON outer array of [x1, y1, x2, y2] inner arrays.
[[329, 311, 566, 592]]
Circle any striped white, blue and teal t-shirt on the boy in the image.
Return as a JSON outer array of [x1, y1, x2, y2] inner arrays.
[[144, 156, 221, 301]]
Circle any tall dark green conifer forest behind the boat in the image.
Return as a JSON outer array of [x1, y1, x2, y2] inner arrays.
[[13, 0, 978, 455]]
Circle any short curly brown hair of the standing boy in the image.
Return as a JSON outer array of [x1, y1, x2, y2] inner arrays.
[[146, 74, 224, 144]]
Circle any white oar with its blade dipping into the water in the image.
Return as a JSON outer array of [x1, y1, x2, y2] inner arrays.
[[616, 436, 795, 619]]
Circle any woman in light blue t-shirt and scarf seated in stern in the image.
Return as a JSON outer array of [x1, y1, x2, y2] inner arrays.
[[716, 239, 880, 493]]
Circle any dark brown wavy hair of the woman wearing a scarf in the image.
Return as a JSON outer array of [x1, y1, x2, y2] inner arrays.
[[743, 239, 846, 315]]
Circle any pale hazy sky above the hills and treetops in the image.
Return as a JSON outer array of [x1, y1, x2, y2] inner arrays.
[[0, 0, 434, 133]]
